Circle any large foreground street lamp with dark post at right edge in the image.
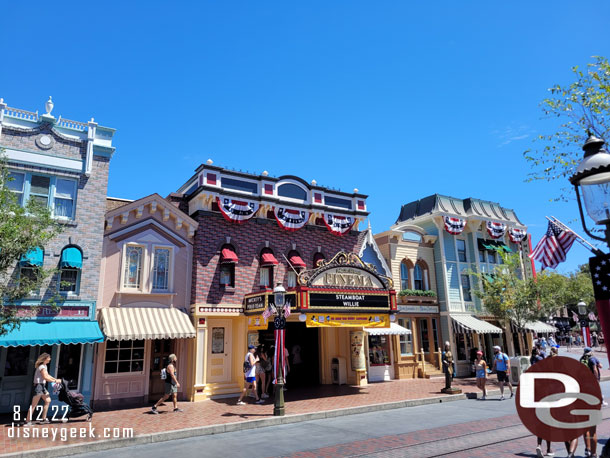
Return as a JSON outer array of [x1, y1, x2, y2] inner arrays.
[[570, 133, 610, 352]]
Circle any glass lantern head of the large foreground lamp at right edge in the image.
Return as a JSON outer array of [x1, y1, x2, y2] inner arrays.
[[570, 134, 610, 246]]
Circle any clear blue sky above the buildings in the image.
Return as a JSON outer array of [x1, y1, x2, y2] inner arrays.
[[0, 0, 610, 271]]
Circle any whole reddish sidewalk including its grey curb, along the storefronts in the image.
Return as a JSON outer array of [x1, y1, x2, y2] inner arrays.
[[0, 371, 610, 457]]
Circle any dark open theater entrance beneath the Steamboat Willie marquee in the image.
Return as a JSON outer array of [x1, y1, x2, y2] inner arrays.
[[258, 322, 320, 387]]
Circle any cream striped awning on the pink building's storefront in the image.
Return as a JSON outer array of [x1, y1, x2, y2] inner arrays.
[[100, 307, 195, 340]]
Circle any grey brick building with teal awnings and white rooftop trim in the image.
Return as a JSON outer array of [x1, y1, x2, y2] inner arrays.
[[0, 98, 115, 412]]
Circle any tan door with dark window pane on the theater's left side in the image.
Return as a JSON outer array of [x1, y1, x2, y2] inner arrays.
[[207, 320, 230, 383]]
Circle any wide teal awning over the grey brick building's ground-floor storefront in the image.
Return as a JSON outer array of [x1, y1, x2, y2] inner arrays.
[[0, 320, 104, 347]]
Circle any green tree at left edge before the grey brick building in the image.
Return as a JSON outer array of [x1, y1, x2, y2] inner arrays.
[[0, 150, 62, 336]]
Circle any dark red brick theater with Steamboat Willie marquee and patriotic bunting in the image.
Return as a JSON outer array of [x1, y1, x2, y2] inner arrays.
[[170, 161, 395, 400]]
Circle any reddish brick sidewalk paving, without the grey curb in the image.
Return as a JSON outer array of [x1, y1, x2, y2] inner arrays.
[[0, 372, 508, 453]]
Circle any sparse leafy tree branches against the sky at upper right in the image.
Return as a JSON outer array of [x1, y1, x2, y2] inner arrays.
[[523, 56, 610, 190]]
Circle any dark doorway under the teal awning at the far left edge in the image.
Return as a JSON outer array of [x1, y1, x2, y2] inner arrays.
[[0, 347, 35, 413]]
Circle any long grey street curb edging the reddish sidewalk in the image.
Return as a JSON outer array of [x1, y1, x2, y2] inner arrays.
[[5, 376, 610, 458]]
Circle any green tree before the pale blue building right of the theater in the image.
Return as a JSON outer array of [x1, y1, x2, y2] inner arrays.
[[471, 251, 544, 328]]
